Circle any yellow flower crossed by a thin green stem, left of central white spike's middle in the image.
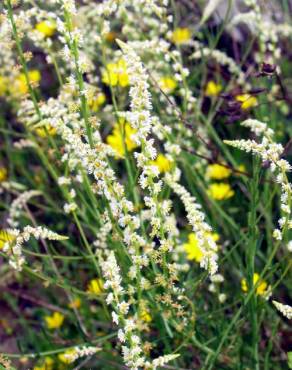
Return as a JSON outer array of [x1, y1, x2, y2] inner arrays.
[[106, 120, 138, 157]]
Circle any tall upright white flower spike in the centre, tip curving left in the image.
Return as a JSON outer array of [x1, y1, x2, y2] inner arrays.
[[119, 41, 175, 251]]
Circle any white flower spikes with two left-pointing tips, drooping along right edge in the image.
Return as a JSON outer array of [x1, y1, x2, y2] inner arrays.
[[224, 119, 292, 241]]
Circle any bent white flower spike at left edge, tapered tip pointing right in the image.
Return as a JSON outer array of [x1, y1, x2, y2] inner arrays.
[[3, 226, 67, 271]]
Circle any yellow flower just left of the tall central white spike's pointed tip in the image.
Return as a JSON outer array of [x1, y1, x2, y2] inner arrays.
[[102, 59, 129, 87]]
